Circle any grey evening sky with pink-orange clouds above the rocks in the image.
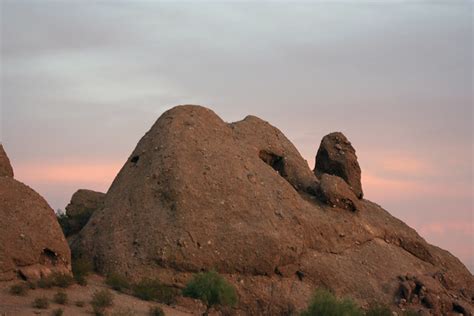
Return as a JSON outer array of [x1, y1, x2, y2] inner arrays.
[[0, 0, 474, 271]]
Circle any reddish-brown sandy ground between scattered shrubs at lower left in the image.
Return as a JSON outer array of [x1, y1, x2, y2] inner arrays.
[[0, 275, 192, 316]]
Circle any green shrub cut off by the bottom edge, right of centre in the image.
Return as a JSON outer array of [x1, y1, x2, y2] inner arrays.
[[301, 290, 363, 316]]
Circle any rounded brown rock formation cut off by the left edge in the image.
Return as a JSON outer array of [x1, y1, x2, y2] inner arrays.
[[0, 147, 71, 280]]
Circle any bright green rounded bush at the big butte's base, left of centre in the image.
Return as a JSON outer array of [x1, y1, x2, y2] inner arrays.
[[183, 271, 237, 306]]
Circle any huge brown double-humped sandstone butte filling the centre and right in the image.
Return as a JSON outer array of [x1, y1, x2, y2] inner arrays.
[[73, 106, 474, 315]]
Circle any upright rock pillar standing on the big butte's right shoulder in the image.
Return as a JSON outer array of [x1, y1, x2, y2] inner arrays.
[[314, 132, 363, 198]]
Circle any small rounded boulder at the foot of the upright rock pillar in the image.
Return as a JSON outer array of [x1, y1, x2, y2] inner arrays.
[[320, 173, 359, 212]]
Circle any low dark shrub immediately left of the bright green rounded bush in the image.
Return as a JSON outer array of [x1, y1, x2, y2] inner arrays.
[[132, 279, 178, 305]]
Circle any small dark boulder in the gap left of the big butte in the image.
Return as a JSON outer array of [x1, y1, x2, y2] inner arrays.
[[66, 189, 105, 237]]
